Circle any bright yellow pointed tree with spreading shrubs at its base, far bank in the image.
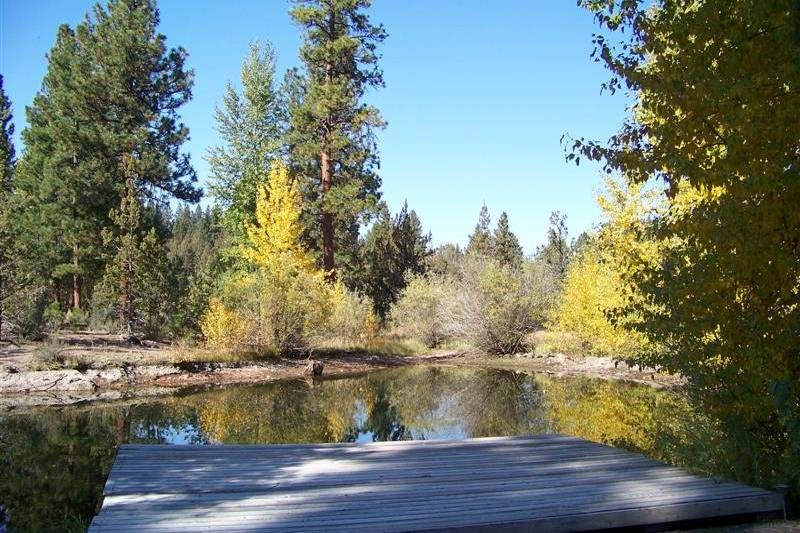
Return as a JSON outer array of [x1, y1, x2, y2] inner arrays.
[[202, 162, 377, 353]]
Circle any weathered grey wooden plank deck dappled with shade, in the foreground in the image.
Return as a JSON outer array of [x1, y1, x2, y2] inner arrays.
[[89, 435, 783, 533]]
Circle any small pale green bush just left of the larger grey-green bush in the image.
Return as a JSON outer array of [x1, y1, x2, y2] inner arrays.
[[389, 274, 454, 348]]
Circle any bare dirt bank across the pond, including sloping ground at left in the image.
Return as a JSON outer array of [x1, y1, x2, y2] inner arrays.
[[0, 333, 681, 412]]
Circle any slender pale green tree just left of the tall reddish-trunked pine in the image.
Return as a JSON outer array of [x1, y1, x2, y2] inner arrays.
[[207, 43, 287, 244]]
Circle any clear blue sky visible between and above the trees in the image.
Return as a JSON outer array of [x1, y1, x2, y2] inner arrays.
[[0, 0, 626, 253]]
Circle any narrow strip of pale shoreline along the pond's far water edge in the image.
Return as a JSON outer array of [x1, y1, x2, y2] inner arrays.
[[0, 344, 683, 414]]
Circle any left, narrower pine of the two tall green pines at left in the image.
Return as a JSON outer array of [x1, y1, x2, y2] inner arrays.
[[15, 26, 96, 308]]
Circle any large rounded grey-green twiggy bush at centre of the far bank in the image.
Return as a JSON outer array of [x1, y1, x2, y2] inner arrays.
[[445, 257, 558, 354]]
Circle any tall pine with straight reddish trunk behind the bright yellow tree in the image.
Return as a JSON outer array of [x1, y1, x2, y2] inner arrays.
[[290, 0, 386, 278]]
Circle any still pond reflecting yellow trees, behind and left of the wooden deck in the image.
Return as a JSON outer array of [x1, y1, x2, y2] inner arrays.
[[0, 366, 788, 531]]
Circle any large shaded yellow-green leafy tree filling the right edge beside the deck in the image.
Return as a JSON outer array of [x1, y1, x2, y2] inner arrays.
[[569, 0, 800, 502]]
